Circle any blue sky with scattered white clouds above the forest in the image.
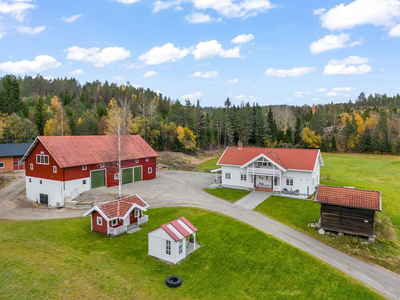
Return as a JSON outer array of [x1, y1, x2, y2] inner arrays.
[[0, 0, 400, 106]]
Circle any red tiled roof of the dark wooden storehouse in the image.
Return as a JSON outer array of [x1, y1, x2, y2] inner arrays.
[[315, 185, 381, 211]]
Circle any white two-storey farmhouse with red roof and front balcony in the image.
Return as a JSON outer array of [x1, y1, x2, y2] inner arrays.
[[214, 143, 324, 195]]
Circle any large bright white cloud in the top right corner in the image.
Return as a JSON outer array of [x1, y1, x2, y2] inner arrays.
[[320, 0, 400, 30]]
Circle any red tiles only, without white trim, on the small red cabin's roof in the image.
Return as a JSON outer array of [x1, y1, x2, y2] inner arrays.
[[98, 195, 148, 219]]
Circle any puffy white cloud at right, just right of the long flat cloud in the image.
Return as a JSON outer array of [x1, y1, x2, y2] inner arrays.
[[323, 56, 371, 75]]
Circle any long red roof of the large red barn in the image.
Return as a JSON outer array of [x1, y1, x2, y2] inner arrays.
[[30, 135, 158, 168]]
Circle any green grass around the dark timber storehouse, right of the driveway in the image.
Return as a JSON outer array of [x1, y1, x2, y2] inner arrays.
[[256, 153, 400, 274]]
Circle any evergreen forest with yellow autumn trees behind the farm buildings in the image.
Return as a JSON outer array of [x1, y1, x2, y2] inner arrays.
[[0, 75, 400, 154]]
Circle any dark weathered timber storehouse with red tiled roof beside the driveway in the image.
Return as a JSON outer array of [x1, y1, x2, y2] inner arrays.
[[314, 185, 382, 237]]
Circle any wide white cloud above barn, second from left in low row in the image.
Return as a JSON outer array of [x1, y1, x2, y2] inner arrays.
[[64, 46, 131, 67]]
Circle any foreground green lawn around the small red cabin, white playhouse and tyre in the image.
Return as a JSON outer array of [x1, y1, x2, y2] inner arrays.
[[0, 208, 383, 299]]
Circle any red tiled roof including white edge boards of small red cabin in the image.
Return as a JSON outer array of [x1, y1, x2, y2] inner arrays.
[[83, 195, 149, 221]]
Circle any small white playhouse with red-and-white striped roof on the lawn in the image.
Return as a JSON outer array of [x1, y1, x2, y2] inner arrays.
[[147, 217, 197, 264]]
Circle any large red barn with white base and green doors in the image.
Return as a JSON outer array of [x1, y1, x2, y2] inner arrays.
[[22, 135, 158, 207]]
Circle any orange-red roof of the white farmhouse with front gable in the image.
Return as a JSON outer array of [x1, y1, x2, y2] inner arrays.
[[218, 147, 319, 171]]
